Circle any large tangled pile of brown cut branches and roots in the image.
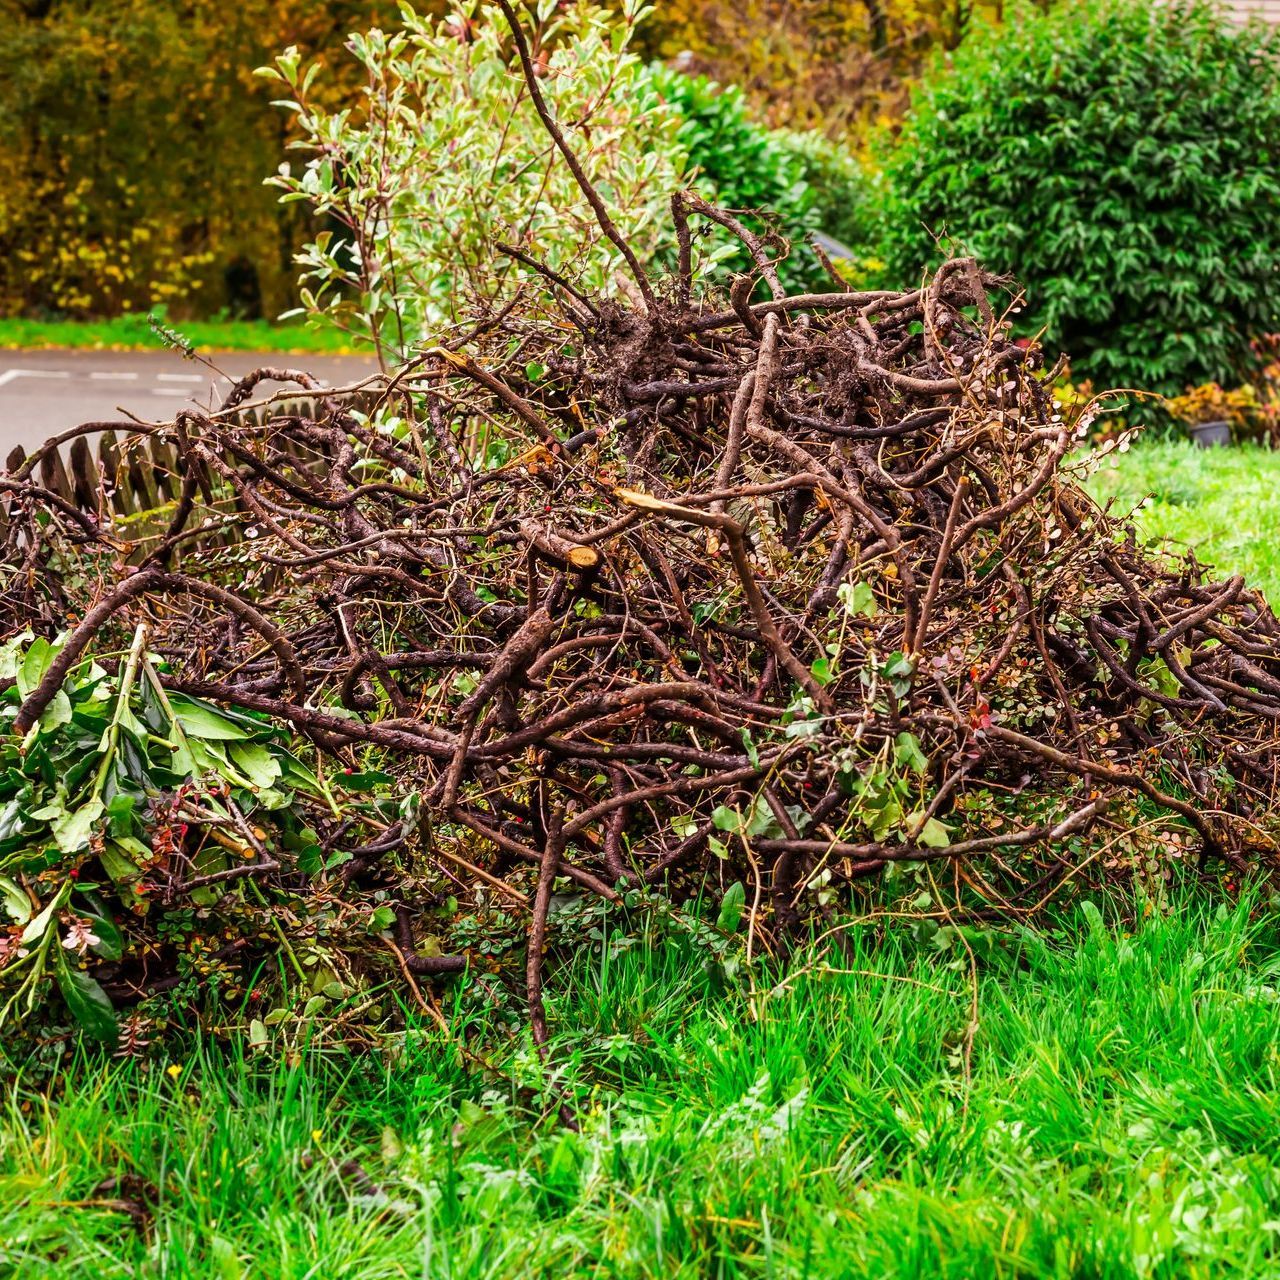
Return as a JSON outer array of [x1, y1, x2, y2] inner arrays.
[[0, 5, 1280, 1028]]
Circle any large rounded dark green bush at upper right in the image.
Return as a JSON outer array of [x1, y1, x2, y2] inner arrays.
[[884, 0, 1280, 392]]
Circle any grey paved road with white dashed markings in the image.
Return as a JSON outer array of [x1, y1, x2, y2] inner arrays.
[[0, 347, 378, 462]]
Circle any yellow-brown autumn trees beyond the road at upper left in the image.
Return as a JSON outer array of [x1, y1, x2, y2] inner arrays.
[[0, 0, 394, 315]]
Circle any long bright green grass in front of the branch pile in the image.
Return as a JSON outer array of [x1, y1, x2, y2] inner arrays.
[[0, 905, 1280, 1280]]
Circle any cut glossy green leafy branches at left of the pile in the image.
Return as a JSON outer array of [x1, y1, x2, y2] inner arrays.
[[0, 631, 328, 1041]]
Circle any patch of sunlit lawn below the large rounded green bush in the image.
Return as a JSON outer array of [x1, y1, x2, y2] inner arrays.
[[1091, 442, 1280, 605]]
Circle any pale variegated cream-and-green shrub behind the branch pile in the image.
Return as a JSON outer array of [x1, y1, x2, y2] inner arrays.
[[262, 0, 685, 357]]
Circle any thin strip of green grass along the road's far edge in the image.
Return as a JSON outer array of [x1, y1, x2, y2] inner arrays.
[[0, 315, 353, 355]]
